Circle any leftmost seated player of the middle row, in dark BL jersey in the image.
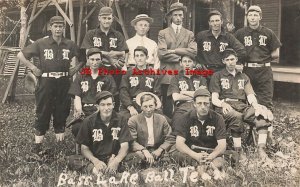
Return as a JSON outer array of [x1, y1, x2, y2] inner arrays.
[[69, 48, 117, 137]]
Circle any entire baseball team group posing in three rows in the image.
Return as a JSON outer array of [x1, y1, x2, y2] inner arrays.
[[17, 2, 281, 178]]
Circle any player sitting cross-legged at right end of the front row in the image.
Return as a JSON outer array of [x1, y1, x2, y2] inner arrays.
[[170, 88, 226, 179]]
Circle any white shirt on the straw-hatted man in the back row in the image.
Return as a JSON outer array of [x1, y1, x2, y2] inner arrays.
[[126, 34, 160, 69]]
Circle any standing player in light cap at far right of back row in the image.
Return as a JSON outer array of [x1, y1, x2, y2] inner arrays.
[[235, 6, 281, 110]]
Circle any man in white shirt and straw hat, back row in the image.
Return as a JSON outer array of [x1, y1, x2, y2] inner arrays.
[[126, 14, 160, 69]]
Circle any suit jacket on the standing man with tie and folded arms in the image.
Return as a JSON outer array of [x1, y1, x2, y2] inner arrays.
[[158, 26, 197, 84]]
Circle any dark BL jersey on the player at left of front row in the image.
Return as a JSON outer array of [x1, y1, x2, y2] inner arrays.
[[76, 112, 133, 160]]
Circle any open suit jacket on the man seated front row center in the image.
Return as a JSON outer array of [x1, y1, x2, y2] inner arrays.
[[128, 113, 173, 152]]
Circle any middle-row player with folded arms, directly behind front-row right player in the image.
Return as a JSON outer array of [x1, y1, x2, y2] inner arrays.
[[168, 53, 207, 124]]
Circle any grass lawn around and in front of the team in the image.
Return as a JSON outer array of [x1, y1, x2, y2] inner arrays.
[[0, 78, 300, 187]]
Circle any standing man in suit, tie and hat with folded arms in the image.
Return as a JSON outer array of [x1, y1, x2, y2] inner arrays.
[[158, 3, 197, 117]]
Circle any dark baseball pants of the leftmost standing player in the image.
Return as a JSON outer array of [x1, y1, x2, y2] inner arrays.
[[35, 77, 71, 136]]
